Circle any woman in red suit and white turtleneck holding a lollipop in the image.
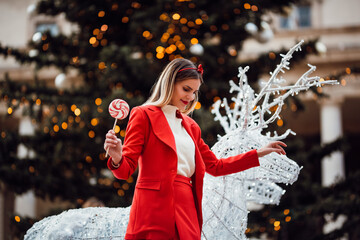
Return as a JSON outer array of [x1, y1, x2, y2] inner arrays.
[[104, 59, 286, 240]]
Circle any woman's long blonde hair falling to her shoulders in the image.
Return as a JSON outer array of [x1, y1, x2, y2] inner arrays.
[[143, 58, 203, 114]]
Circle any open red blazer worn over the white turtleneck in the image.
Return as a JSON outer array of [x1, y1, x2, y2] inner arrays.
[[108, 105, 259, 239]]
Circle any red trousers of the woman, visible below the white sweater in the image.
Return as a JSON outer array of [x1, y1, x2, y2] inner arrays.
[[174, 175, 201, 240]]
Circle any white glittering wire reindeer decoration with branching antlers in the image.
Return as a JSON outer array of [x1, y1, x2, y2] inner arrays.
[[25, 41, 337, 240]]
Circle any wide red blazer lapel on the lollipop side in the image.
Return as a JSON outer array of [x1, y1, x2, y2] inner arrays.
[[144, 105, 176, 153]]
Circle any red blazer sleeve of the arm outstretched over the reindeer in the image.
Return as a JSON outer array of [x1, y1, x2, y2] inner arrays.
[[195, 120, 260, 176]]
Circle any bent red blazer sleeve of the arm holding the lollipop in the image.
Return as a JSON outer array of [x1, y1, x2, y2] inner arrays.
[[107, 107, 148, 179]]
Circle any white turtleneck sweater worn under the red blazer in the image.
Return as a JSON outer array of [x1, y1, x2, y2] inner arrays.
[[161, 105, 195, 177]]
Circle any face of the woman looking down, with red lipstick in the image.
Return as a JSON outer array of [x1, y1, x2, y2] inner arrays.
[[170, 79, 201, 111]]
